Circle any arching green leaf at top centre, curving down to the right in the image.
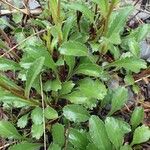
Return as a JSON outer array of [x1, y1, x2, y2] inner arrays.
[[67, 2, 94, 22]]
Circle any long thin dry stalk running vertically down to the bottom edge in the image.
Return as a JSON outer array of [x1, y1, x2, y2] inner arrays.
[[40, 76, 46, 150]]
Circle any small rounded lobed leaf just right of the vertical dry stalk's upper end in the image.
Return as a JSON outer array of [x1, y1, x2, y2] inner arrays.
[[44, 79, 61, 92]]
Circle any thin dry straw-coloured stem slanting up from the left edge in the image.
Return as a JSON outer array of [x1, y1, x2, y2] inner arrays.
[[0, 30, 46, 58]]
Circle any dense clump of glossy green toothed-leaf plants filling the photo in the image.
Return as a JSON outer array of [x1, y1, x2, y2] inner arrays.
[[0, 0, 150, 150]]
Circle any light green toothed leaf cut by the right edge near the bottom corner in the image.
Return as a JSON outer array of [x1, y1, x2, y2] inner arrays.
[[131, 125, 150, 146]]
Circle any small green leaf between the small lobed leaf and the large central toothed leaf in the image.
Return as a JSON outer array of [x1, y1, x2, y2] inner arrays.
[[59, 81, 75, 95]]
